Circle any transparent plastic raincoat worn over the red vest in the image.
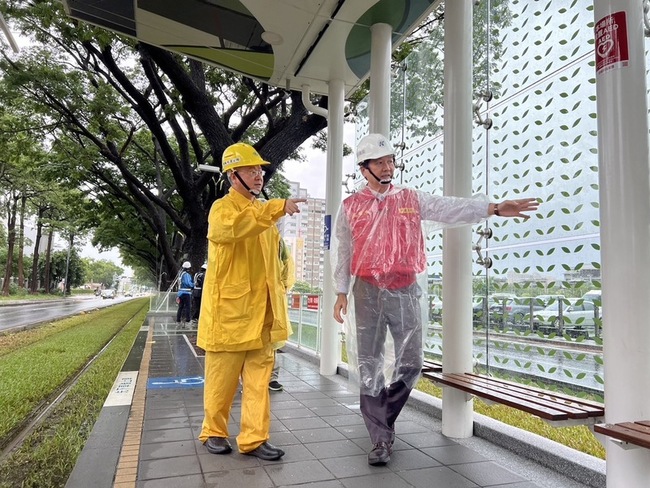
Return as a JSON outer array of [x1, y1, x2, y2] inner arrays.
[[332, 185, 489, 397]]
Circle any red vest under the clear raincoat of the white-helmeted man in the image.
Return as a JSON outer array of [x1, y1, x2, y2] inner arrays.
[[343, 188, 426, 290]]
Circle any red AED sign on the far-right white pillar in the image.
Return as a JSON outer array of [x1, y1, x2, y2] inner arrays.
[[594, 11, 630, 74]]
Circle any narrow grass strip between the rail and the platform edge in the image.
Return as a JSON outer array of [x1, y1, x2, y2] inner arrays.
[[0, 301, 149, 488]]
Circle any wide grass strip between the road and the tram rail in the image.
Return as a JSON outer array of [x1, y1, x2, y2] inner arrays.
[[0, 299, 148, 446]]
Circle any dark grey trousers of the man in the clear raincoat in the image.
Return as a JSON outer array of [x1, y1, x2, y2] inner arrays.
[[352, 279, 422, 444]]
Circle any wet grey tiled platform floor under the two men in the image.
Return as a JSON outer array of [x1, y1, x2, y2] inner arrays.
[[109, 323, 600, 488]]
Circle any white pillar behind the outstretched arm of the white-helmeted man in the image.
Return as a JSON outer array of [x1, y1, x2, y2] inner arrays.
[[442, 0, 473, 438]]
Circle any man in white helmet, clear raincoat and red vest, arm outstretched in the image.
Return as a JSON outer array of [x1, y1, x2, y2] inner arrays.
[[333, 134, 537, 466]]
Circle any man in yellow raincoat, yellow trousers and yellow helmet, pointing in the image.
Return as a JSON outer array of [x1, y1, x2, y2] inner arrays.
[[197, 143, 305, 460]]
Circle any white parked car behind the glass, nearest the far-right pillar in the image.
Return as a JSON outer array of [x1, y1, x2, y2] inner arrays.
[[533, 298, 602, 337]]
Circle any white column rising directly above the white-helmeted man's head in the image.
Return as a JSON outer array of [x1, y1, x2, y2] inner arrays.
[[368, 24, 393, 135]]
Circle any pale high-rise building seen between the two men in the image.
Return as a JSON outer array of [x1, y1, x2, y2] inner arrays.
[[278, 181, 325, 288]]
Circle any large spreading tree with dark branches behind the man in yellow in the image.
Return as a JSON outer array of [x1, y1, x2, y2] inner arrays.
[[0, 1, 327, 287]]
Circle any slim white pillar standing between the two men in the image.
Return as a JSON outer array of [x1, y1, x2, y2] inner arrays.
[[320, 80, 345, 376]]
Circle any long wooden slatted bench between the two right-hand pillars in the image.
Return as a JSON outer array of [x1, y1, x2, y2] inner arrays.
[[422, 371, 605, 427]]
